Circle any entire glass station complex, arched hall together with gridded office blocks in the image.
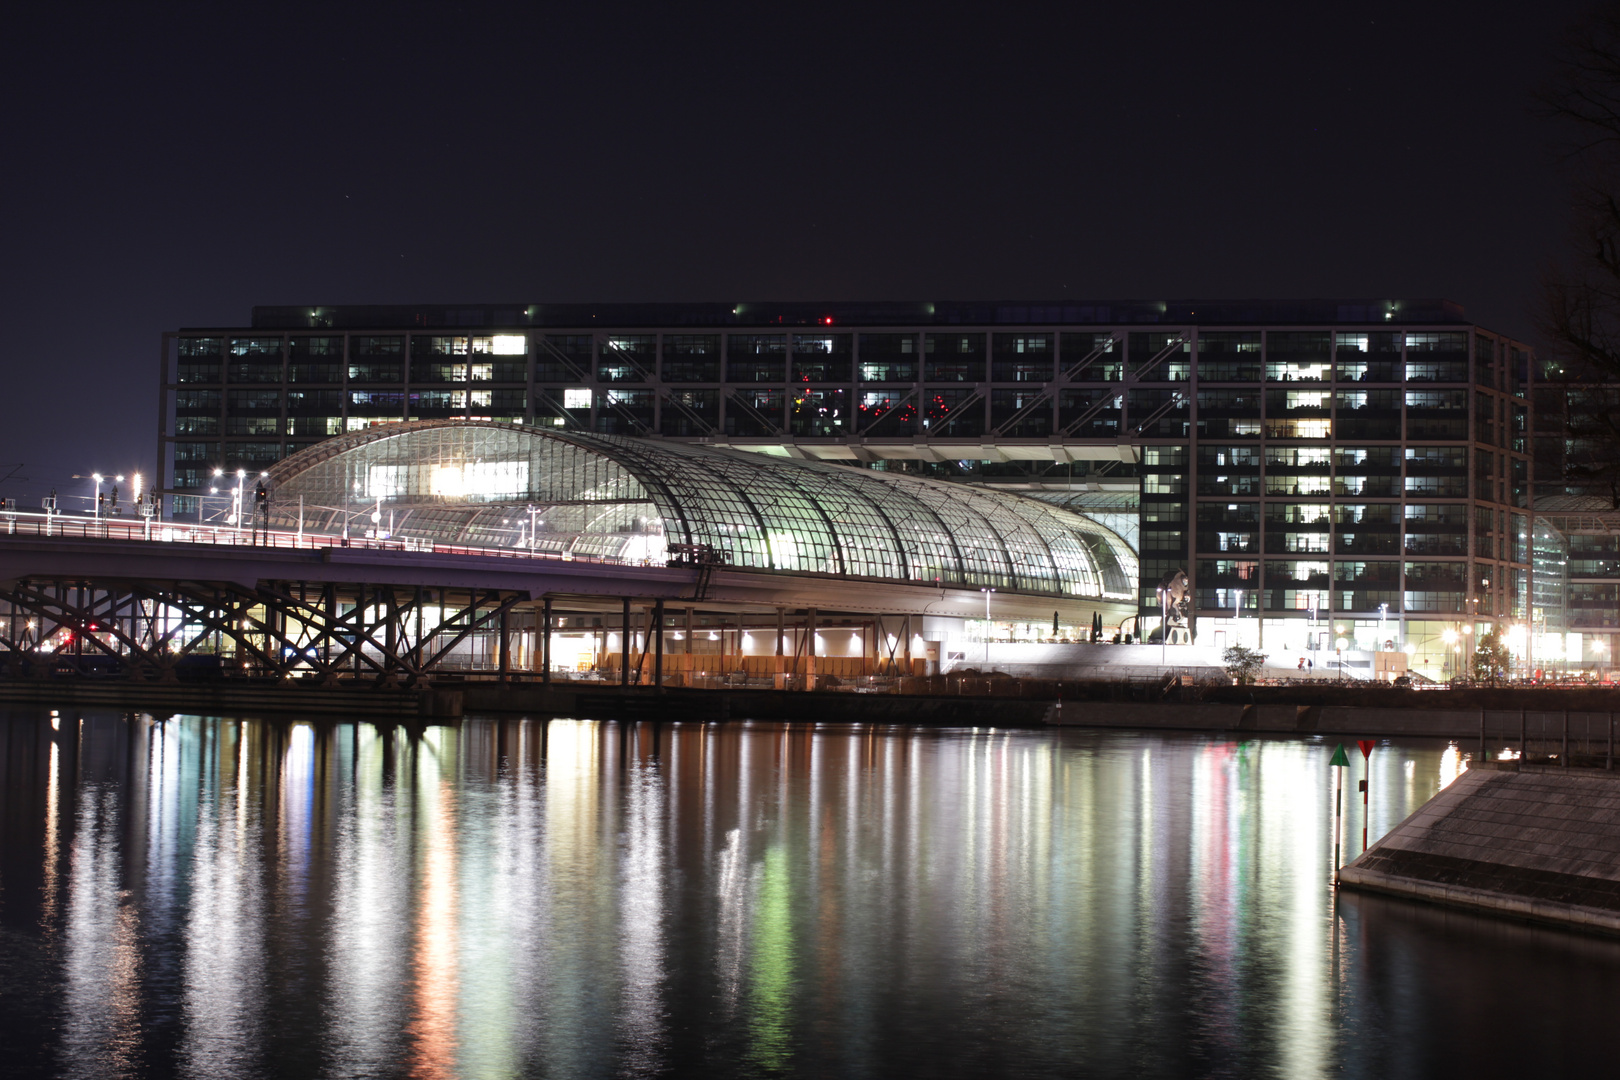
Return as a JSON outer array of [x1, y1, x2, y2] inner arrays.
[[157, 300, 1615, 678]]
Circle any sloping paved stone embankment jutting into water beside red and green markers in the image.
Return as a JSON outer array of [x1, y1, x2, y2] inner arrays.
[[1340, 763, 1620, 934]]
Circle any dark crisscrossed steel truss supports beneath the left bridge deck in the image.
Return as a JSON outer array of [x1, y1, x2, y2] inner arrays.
[[0, 578, 527, 685]]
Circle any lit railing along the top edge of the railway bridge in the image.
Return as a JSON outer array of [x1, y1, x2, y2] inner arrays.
[[0, 510, 650, 567]]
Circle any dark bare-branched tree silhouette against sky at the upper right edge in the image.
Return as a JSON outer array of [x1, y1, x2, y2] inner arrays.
[[1536, 2, 1620, 508]]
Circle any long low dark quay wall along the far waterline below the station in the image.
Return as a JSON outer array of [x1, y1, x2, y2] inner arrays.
[[0, 678, 1620, 738]]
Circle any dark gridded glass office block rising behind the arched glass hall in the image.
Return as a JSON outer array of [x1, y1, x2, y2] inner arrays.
[[159, 300, 1581, 678]]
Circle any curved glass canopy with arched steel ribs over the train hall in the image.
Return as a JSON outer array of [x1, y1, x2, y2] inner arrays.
[[271, 419, 1137, 601]]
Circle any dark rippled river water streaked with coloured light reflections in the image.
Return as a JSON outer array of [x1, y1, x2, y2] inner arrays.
[[0, 711, 1620, 1078]]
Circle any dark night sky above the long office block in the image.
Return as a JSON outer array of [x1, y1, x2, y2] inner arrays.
[[0, 0, 1581, 505]]
